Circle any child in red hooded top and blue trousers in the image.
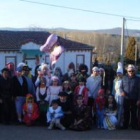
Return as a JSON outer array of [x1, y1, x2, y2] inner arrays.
[[93, 89, 106, 128]]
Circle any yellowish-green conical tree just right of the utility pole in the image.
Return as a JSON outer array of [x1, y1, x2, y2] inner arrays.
[[125, 37, 136, 64]]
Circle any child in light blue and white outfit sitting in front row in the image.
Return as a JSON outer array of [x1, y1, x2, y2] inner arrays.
[[47, 100, 66, 130]]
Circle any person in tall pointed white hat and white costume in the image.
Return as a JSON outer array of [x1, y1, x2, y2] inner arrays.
[[112, 62, 124, 128]]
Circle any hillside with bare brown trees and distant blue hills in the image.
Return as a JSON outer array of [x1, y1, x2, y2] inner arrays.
[[0, 28, 140, 62]]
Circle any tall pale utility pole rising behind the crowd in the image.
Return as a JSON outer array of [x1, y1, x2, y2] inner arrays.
[[120, 18, 125, 65]]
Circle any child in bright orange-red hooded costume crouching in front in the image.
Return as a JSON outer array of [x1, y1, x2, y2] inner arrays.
[[23, 94, 39, 125]]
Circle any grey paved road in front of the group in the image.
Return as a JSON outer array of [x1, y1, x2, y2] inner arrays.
[[0, 125, 140, 140]]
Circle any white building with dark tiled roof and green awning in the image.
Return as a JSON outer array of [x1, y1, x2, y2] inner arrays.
[[0, 31, 93, 74]]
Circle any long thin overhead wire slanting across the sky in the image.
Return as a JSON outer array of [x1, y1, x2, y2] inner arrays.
[[20, 0, 140, 20]]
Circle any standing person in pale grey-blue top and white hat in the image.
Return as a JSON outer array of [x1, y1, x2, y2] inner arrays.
[[86, 67, 102, 107]]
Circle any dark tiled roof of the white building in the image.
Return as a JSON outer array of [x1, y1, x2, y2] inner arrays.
[[0, 31, 93, 50]]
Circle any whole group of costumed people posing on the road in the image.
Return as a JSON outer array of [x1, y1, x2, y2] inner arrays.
[[0, 62, 140, 131]]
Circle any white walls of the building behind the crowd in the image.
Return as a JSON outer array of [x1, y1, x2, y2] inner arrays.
[[0, 51, 91, 74]]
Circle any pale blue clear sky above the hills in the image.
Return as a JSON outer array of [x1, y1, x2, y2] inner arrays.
[[0, 0, 140, 30]]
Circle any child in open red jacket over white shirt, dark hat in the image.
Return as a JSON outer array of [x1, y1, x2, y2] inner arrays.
[[74, 78, 88, 105]]
